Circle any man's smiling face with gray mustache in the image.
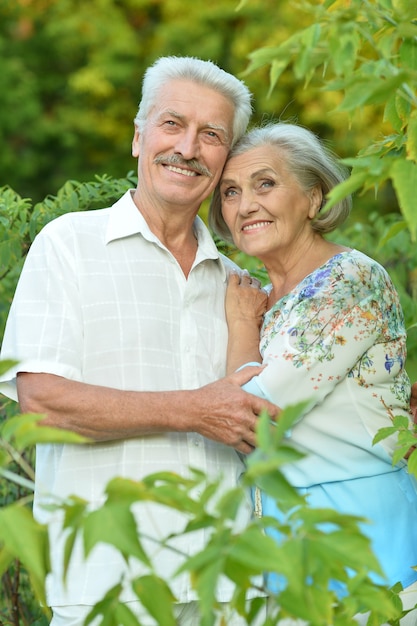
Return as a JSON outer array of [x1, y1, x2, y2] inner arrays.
[[132, 80, 234, 212]]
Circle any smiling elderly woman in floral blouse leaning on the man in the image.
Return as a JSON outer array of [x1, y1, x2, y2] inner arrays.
[[210, 123, 417, 624]]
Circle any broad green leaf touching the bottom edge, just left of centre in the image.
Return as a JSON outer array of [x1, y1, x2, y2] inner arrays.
[[132, 574, 177, 626]]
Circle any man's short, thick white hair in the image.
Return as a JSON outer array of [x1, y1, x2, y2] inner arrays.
[[134, 56, 252, 146]]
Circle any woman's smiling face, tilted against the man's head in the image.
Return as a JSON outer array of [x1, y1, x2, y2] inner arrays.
[[220, 145, 322, 261]]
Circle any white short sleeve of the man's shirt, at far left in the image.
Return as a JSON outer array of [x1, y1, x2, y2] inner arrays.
[[0, 216, 82, 399]]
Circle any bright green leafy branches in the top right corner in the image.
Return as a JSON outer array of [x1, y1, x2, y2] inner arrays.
[[242, 0, 417, 241]]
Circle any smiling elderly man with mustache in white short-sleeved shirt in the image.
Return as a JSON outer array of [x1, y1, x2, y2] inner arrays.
[[1, 57, 277, 626]]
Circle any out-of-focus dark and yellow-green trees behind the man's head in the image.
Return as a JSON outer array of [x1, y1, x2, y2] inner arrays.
[[0, 0, 392, 214]]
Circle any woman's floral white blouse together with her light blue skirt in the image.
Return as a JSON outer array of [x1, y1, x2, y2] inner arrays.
[[244, 250, 417, 590]]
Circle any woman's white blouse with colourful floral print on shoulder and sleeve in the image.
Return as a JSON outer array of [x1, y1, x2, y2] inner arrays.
[[242, 250, 410, 487]]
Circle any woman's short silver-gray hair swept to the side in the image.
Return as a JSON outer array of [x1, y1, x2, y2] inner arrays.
[[209, 122, 352, 241]]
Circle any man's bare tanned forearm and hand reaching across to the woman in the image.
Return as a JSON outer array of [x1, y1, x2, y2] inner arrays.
[[17, 367, 278, 454]]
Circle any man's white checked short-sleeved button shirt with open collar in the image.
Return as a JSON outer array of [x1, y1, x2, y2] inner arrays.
[[0, 192, 250, 605]]
